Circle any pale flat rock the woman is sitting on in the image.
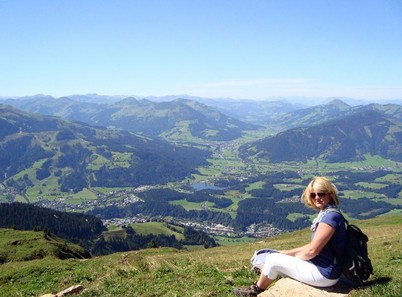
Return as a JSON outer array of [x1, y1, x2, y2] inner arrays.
[[258, 278, 350, 297]]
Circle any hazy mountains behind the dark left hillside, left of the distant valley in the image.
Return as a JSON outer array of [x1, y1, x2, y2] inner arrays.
[[3, 96, 257, 141]]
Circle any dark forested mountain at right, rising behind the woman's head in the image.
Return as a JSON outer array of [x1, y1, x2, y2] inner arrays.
[[241, 110, 402, 163]]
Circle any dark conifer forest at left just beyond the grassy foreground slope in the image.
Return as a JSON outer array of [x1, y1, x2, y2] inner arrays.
[[0, 203, 217, 256]]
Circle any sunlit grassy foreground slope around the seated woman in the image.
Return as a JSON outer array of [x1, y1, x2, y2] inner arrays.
[[0, 214, 402, 297]]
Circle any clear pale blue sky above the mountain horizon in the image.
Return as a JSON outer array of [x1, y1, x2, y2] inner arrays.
[[0, 0, 402, 99]]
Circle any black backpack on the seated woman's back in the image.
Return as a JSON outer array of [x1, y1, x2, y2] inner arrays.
[[328, 208, 373, 286]]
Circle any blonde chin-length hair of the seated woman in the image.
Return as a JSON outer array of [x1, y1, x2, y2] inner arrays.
[[301, 176, 339, 210]]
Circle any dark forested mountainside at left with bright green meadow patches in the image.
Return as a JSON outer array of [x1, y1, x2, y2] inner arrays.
[[0, 105, 210, 192]]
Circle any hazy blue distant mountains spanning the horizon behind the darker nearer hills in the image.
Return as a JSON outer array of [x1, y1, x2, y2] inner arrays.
[[0, 94, 402, 141]]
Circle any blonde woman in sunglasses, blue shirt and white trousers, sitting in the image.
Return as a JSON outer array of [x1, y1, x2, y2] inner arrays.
[[234, 177, 346, 296]]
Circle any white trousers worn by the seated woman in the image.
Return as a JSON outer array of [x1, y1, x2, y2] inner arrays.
[[262, 253, 338, 287]]
